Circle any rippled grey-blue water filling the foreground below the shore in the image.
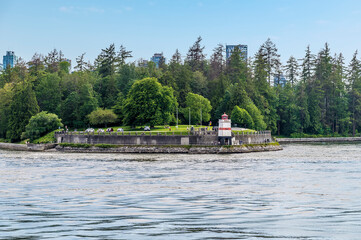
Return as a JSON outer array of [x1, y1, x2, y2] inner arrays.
[[0, 144, 361, 240]]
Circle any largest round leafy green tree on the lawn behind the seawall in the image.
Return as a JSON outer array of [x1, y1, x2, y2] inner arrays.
[[124, 78, 177, 127]]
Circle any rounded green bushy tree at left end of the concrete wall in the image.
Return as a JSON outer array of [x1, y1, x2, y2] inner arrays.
[[22, 111, 63, 141]]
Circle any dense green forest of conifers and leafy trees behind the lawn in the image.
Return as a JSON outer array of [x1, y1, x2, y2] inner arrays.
[[0, 37, 361, 142]]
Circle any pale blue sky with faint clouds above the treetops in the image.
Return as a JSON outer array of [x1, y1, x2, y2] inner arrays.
[[0, 0, 361, 66]]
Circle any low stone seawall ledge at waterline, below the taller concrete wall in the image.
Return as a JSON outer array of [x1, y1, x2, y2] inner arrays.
[[56, 144, 283, 154]]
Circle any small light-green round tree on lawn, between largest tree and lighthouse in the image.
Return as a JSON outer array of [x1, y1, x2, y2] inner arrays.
[[182, 93, 212, 124]]
